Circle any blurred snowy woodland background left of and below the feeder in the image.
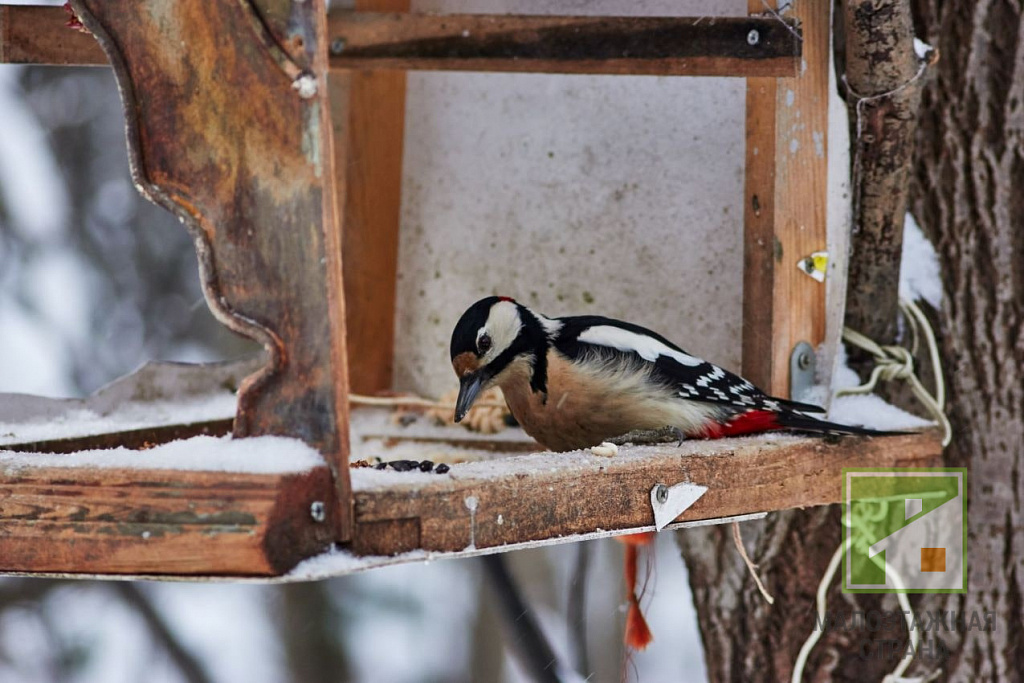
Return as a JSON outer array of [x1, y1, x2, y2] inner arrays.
[[0, 49, 705, 683]]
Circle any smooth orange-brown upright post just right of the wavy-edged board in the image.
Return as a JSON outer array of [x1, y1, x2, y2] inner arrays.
[[329, 0, 409, 394]]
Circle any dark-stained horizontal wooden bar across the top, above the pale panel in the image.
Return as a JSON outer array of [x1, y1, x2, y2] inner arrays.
[[330, 11, 800, 77]]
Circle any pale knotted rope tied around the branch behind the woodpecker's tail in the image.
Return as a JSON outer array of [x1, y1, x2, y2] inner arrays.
[[836, 299, 953, 446]]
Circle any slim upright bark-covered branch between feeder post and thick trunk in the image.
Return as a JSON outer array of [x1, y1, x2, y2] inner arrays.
[[843, 0, 925, 344]]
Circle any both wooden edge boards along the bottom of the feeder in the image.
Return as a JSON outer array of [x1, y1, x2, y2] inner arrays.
[[0, 413, 941, 579]]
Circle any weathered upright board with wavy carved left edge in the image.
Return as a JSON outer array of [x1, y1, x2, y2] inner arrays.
[[73, 0, 348, 533]]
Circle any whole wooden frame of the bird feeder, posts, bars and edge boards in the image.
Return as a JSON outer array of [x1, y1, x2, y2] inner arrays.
[[0, 0, 941, 578]]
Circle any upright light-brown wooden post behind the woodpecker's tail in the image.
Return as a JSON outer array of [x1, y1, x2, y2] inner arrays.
[[743, 0, 830, 396]]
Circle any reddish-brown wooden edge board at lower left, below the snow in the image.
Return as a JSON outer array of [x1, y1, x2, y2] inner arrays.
[[0, 461, 337, 577]]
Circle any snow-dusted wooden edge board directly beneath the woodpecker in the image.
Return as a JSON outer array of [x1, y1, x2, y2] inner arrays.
[[353, 432, 942, 555]]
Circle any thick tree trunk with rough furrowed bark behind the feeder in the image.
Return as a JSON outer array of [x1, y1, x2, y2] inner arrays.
[[678, 0, 1024, 682]]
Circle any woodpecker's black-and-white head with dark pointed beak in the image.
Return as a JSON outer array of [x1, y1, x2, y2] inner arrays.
[[452, 296, 552, 422]]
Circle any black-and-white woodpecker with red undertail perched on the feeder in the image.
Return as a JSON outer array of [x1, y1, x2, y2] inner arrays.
[[452, 296, 897, 451]]
